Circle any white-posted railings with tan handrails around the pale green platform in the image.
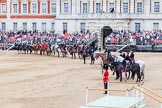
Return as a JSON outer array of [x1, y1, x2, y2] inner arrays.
[[86, 81, 162, 108]]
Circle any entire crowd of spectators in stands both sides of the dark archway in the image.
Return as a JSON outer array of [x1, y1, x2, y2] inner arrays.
[[0, 30, 162, 45]]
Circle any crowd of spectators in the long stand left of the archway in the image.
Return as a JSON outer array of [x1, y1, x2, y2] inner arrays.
[[0, 30, 95, 44]]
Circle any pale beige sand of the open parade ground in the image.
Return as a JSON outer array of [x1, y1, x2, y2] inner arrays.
[[0, 51, 162, 108]]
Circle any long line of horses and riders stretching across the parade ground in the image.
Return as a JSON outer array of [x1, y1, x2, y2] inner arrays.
[[15, 43, 145, 82]]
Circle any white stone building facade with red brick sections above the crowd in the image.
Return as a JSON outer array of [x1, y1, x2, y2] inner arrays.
[[0, 0, 162, 33]]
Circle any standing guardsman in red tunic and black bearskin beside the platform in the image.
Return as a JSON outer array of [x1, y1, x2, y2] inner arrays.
[[103, 66, 109, 94]]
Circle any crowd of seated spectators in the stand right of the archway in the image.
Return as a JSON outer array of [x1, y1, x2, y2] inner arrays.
[[105, 30, 162, 45]]
